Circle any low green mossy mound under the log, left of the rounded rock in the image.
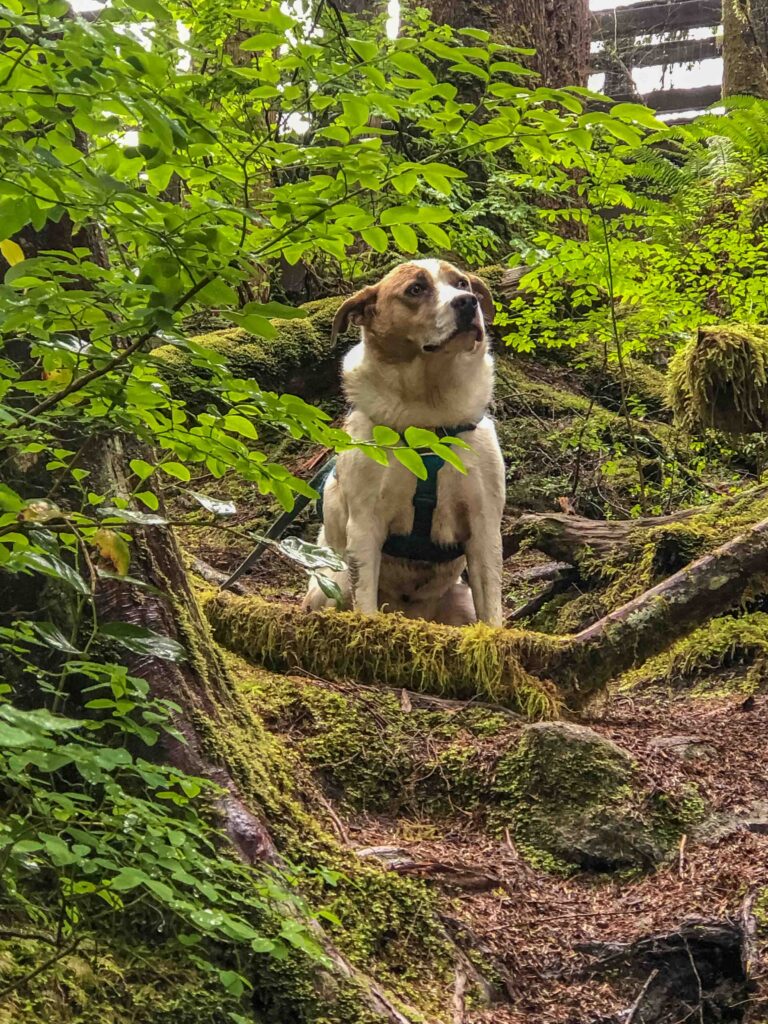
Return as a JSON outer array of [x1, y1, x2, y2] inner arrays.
[[241, 670, 520, 818]]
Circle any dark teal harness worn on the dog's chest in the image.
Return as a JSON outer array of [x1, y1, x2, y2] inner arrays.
[[313, 423, 477, 564]]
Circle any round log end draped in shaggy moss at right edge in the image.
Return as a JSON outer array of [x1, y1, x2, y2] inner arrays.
[[669, 325, 768, 434]]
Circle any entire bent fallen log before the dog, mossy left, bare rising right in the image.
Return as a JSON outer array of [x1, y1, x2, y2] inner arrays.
[[205, 519, 768, 719]]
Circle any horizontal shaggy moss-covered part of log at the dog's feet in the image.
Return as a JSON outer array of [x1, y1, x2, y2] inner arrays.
[[205, 594, 559, 720]]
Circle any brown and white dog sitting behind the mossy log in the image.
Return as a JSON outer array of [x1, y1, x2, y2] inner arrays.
[[304, 259, 505, 626]]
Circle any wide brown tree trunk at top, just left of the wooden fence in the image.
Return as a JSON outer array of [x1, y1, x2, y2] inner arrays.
[[428, 0, 592, 88]]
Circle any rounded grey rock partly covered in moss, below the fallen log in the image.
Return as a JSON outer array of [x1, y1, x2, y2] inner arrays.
[[496, 722, 700, 872]]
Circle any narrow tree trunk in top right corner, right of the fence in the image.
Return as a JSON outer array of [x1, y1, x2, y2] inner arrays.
[[723, 0, 768, 99]]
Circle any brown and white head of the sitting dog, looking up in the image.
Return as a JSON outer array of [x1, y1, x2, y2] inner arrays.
[[333, 259, 495, 362]]
